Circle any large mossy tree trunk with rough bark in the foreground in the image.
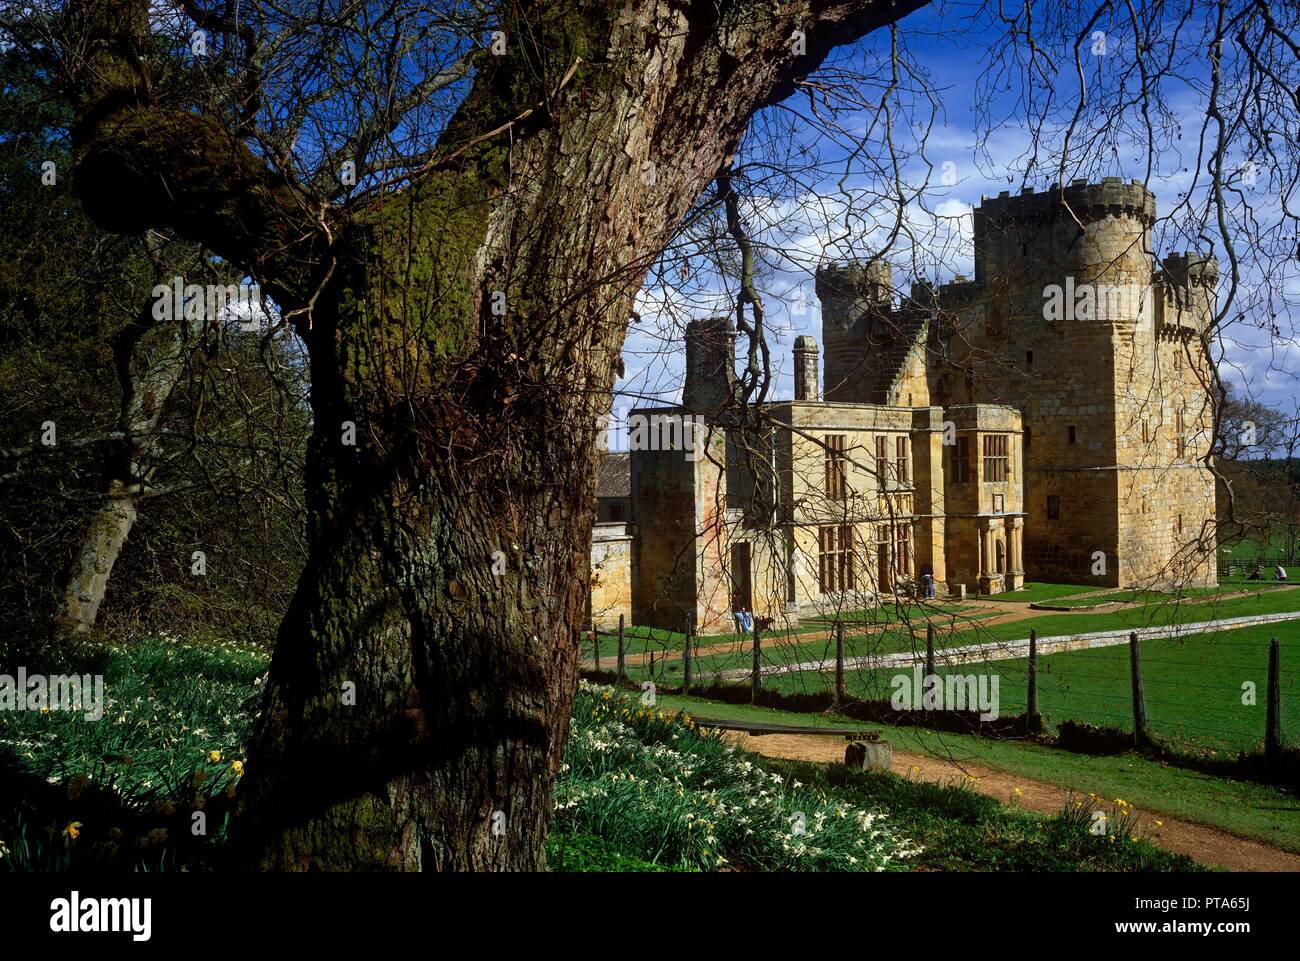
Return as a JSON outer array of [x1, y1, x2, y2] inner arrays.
[[65, 0, 920, 870]]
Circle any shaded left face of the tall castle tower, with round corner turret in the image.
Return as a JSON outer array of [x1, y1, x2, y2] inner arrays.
[[945, 178, 1170, 584]]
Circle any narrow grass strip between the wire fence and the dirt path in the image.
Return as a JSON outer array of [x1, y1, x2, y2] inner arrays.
[[659, 696, 1300, 852]]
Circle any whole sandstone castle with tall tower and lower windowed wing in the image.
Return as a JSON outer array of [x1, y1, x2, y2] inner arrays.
[[592, 178, 1217, 632]]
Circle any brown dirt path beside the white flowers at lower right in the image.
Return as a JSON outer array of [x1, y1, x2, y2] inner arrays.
[[731, 733, 1300, 871]]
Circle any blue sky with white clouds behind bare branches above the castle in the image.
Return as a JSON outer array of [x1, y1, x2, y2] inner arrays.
[[614, 4, 1300, 436]]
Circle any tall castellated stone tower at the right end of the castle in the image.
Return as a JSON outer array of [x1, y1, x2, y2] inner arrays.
[[931, 177, 1214, 585]]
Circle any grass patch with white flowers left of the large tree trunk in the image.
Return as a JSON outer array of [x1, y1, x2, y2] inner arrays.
[[0, 635, 268, 871]]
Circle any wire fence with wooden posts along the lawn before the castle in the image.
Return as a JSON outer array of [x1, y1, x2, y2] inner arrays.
[[585, 608, 1300, 756]]
